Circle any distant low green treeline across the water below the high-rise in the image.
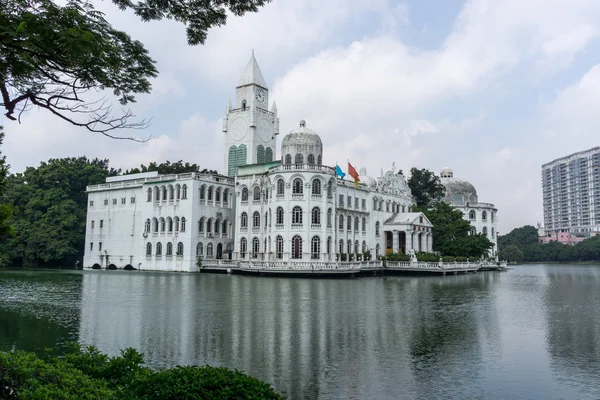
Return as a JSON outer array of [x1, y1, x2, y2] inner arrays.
[[498, 225, 600, 262]]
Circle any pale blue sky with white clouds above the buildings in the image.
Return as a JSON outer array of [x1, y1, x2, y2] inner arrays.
[[0, 0, 600, 234]]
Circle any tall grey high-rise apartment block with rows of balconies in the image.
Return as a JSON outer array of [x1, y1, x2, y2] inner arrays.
[[542, 147, 600, 236]]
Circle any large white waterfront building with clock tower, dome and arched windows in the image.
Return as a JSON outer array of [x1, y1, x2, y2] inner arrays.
[[84, 55, 433, 271]]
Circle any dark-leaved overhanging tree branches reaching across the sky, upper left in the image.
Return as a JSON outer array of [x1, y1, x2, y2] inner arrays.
[[0, 0, 270, 139]]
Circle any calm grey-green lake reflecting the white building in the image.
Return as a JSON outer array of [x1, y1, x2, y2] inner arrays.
[[0, 265, 600, 399]]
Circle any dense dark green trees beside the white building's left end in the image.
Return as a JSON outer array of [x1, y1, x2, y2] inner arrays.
[[0, 157, 118, 266]]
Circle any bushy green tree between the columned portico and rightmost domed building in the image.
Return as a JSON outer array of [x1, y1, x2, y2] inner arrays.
[[415, 202, 493, 259]]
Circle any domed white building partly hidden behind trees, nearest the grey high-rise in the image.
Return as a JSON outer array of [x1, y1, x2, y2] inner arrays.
[[440, 168, 498, 256]]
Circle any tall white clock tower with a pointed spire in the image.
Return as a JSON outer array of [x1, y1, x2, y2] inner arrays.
[[223, 52, 279, 176]]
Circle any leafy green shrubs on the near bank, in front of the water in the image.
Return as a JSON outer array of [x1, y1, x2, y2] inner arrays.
[[0, 344, 282, 400]]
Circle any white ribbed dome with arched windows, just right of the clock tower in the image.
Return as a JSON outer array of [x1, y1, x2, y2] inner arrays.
[[281, 120, 323, 165]]
